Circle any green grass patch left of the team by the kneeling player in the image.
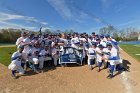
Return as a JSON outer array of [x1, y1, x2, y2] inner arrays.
[[0, 47, 16, 66]]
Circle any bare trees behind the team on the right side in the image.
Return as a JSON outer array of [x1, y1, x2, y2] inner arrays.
[[99, 25, 140, 41]]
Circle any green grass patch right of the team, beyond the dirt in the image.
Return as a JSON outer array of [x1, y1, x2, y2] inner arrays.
[[119, 44, 140, 62]]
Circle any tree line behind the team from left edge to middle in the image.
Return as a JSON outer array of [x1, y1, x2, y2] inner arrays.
[[0, 28, 74, 43]]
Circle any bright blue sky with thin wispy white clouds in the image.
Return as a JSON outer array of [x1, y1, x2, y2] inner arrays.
[[0, 0, 140, 33]]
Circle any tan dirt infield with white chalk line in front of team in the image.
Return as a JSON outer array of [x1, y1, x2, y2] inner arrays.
[[0, 50, 140, 93]]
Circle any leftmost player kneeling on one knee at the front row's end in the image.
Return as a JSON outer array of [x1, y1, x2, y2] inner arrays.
[[8, 46, 24, 79]]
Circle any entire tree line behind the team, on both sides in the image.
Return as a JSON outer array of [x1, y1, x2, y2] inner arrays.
[[0, 25, 140, 43]]
